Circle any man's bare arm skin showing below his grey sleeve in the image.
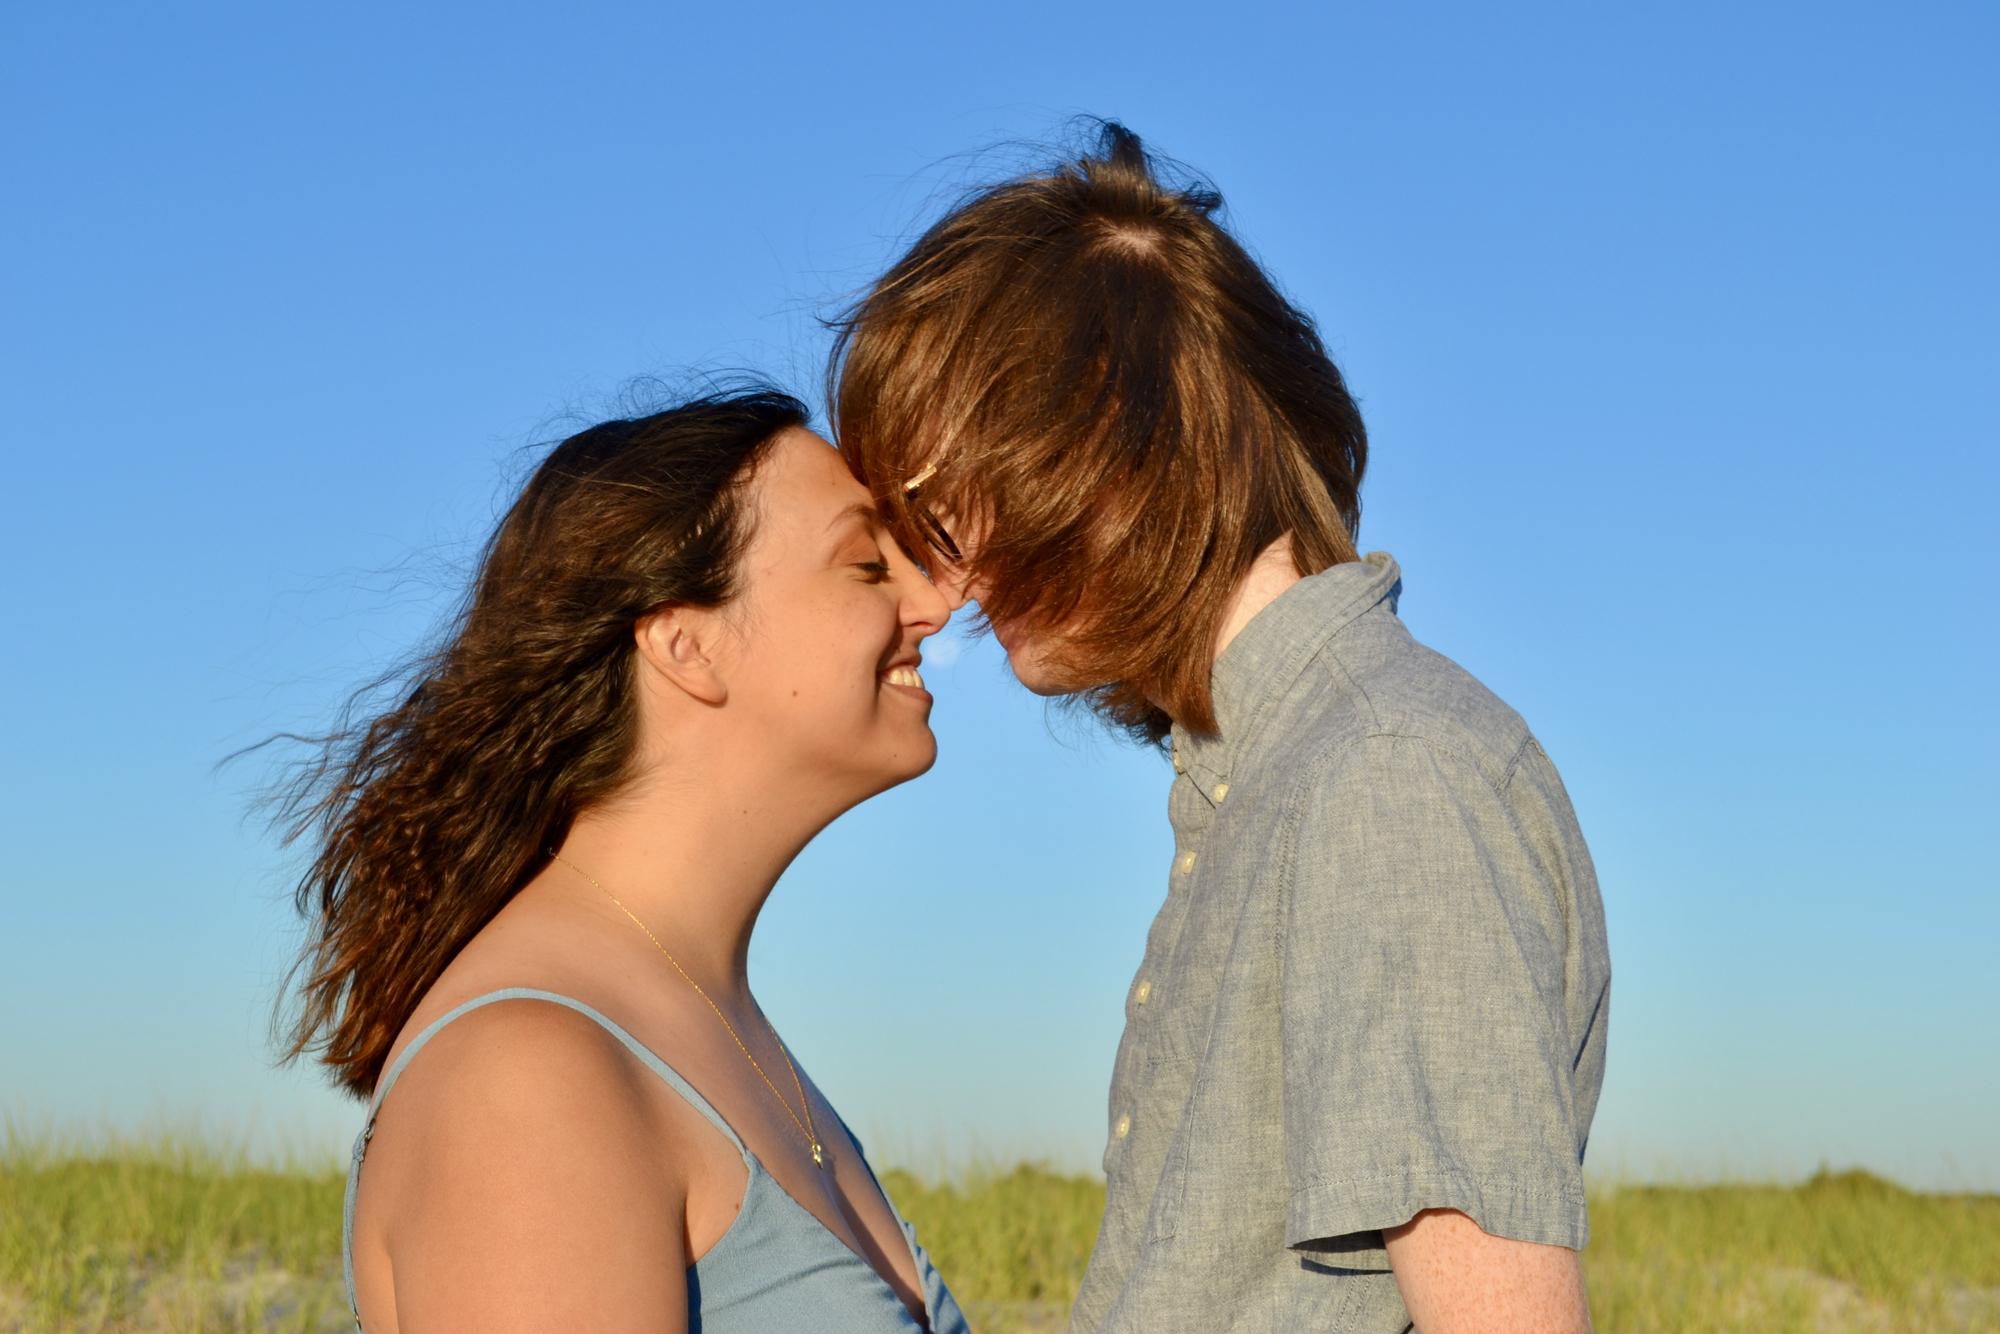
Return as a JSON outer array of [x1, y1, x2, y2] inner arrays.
[[1382, 1208, 1590, 1334]]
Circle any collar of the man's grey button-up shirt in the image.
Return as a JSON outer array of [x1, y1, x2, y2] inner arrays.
[[1172, 552, 1402, 804]]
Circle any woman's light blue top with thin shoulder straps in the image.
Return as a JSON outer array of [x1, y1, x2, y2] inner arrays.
[[340, 986, 970, 1334]]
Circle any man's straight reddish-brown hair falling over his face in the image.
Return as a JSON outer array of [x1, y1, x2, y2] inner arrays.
[[828, 122, 1368, 742]]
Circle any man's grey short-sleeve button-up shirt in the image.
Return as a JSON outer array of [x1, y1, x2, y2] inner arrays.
[[1070, 552, 1610, 1334]]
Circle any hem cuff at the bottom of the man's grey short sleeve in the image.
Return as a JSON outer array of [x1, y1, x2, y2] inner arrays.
[[1284, 1170, 1590, 1268]]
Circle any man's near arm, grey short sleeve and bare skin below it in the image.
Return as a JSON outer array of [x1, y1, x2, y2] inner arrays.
[[1280, 734, 1590, 1334]]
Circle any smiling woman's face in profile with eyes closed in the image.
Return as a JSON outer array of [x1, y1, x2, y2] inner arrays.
[[724, 430, 950, 796]]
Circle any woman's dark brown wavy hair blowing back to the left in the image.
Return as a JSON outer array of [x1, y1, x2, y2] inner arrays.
[[278, 386, 806, 1098]]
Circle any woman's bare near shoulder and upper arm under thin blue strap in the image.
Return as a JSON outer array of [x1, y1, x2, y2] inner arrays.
[[360, 996, 686, 1328]]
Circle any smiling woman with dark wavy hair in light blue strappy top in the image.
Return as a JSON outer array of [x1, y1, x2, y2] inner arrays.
[[274, 390, 964, 1334]]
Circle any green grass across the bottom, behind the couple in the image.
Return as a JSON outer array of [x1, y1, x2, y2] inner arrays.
[[0, 1132, 2000, 1334]]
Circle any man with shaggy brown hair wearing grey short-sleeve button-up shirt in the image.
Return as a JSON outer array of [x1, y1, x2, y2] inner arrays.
[[830, 124, 1610, 1334]]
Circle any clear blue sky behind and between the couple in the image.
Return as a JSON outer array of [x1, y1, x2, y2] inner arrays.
[[0, 4, 2000, 1188]]
